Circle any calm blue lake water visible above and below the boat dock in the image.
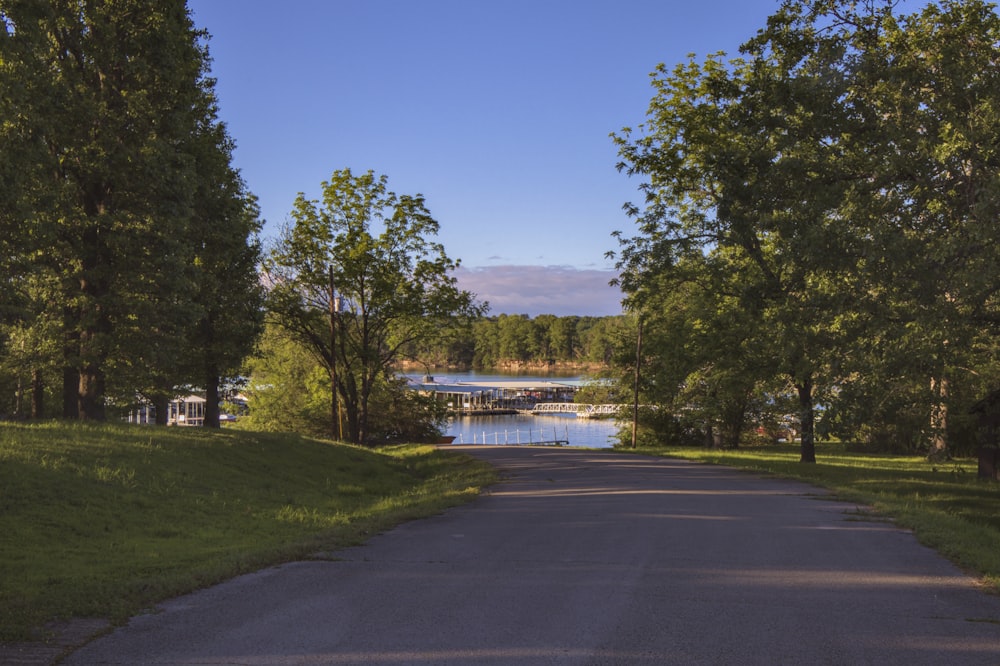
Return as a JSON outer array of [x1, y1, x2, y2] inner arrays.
[[414, 371, 619, 448]]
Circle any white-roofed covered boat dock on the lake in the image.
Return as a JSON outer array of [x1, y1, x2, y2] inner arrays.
[[410, 376, 581, 415]]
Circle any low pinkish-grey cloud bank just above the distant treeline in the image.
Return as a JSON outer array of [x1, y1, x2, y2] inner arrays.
[[455, 266, 622, 317]]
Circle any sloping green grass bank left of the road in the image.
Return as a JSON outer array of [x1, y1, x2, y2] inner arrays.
[[0, 423, 495, 642]]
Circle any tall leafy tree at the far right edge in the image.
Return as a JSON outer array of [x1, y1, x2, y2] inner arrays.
[[843, 0, 1000, 456]]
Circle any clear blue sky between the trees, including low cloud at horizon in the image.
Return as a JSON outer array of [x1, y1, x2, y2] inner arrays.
[[188, 0, 778, 316]]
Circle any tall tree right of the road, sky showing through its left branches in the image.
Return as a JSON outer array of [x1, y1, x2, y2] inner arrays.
[[616, 4, 856, 462]]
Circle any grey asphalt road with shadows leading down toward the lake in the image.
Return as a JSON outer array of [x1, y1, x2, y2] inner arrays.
[[65, 447, 1000, 666]]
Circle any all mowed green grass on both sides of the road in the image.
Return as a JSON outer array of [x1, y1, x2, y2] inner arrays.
[[0, 423, 1000, 642]]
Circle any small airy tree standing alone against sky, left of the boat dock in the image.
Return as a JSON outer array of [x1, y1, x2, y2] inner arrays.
[[265, 169, 482, 444]]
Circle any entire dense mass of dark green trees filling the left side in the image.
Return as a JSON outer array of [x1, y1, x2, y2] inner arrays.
[[0, 0, 262, 425]]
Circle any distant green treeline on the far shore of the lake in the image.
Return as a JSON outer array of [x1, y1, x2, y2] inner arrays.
[[409, 314, 623, 369]]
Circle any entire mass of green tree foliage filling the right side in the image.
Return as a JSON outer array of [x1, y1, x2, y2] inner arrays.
[[615, 0, 1000, 462]]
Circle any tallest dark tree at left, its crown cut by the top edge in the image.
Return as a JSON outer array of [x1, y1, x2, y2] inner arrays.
[[0, 0, 232, 419]]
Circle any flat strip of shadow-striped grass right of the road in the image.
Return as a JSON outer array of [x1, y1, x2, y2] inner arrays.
[[639, 443, 1000, 592]]
